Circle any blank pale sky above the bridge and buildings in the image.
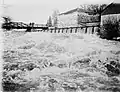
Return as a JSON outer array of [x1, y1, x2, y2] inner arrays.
[[1, 0, 119, 24]]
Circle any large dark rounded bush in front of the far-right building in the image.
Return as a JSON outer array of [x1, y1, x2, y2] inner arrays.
[[99, 16, 119, 40]]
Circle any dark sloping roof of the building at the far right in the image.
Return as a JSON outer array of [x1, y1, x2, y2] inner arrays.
[[102, 3, 120, 15]]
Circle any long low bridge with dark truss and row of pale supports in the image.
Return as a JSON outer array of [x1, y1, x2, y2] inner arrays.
[[2, 22, 99, 34]]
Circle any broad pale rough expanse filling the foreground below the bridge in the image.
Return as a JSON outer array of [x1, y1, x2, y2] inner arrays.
[[3, 31, 120, 92]]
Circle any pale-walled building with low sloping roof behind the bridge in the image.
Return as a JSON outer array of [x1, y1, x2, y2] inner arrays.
[[57, 8, 99, 27]]
